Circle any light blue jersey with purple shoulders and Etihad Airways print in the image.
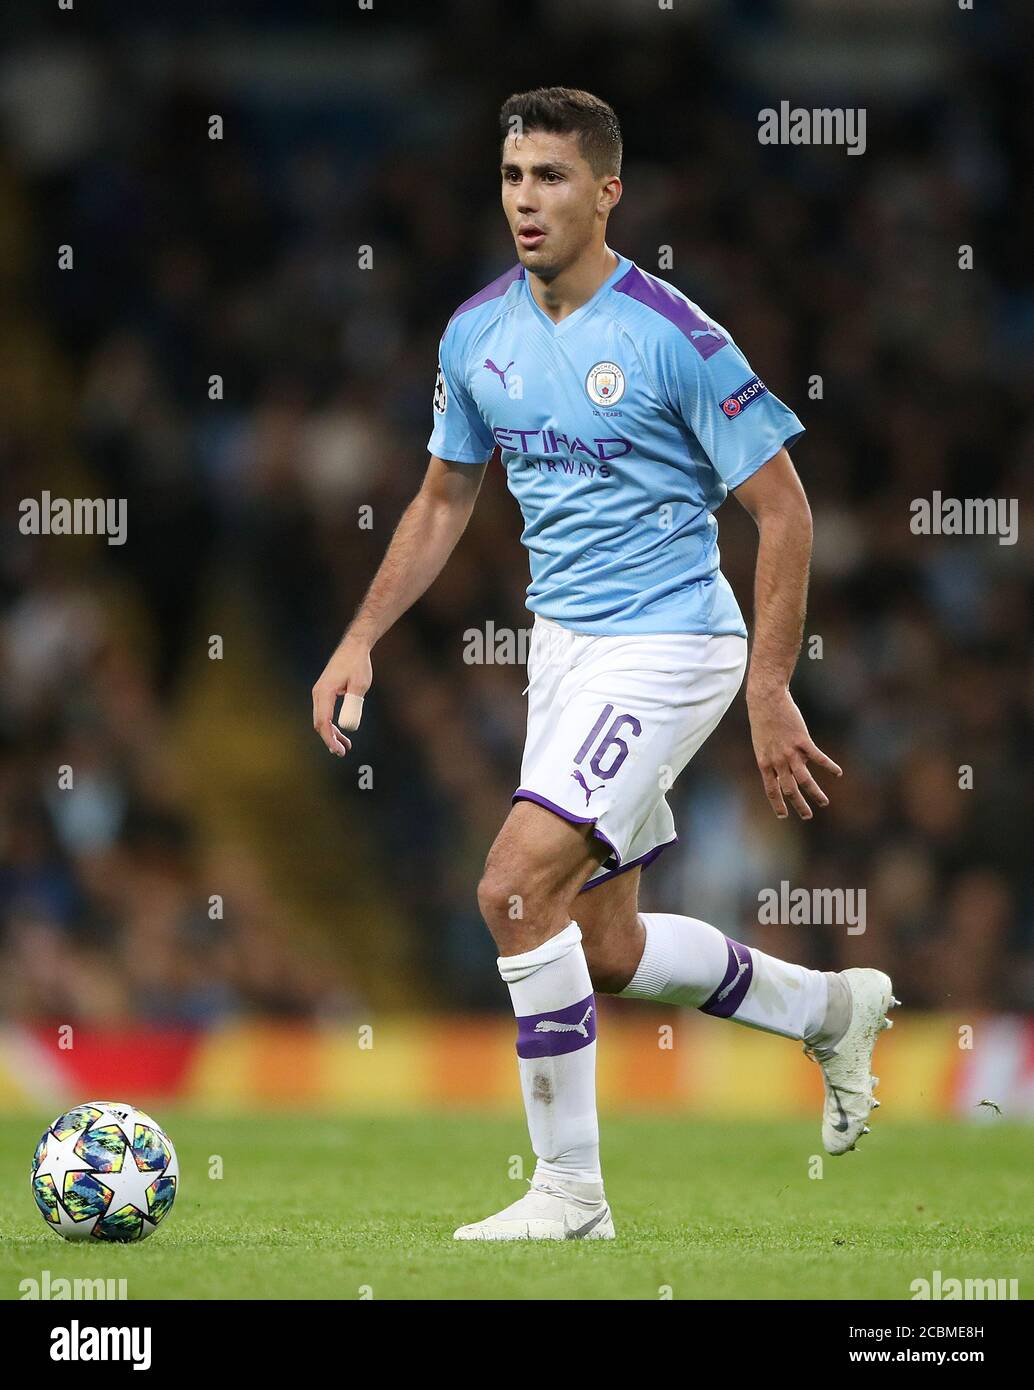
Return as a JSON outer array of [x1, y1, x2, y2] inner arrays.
[[428, 256, 803, 637]]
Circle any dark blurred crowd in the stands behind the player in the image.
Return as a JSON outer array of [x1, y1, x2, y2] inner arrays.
[[0, 0, 1034, 1024]]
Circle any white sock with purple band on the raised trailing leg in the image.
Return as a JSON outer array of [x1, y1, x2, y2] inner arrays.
[[621, 912, 833, 1043]]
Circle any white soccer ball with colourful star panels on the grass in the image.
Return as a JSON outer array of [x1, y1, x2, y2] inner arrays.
[[32, 1101, 179, 1241]]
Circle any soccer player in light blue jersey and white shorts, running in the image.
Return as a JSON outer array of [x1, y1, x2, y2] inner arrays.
[[313, 88, 896, 1240]]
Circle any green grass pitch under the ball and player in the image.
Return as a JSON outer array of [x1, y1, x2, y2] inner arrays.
[[0, 1108, 1034, 1300]]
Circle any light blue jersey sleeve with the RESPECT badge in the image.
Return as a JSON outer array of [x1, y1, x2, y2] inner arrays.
[[657, 329, 805, 488]]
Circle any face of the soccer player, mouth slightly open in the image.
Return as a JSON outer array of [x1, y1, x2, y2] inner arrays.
[[502, 131, 621, 279]]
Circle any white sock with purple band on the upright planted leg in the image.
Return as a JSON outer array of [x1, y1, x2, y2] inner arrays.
[[498, 922, 603, 1183]]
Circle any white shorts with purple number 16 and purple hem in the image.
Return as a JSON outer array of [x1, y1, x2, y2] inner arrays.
[[513, 614, 746, 891]]
